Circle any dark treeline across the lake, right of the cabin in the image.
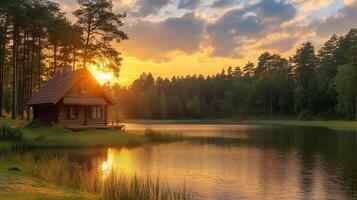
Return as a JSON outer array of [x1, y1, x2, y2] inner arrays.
[[111, 29, 357, 119]]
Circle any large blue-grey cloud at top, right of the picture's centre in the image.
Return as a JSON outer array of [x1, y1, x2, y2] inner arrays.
[[206, 0, 296, 57]]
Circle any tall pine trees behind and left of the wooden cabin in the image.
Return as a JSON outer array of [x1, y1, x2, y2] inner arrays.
[[0, 0, 128, 119]]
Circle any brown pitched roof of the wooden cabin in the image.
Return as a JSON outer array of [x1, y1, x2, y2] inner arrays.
[[27, 68, 116, 106]]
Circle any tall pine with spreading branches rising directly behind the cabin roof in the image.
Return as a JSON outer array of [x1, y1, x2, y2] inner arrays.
[[73, 0, 128, 75]]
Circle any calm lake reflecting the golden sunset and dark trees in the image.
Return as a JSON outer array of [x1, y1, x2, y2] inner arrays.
[[4, 124, 357, 200]]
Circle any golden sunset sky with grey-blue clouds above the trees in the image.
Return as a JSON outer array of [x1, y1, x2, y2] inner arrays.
[[56, 0, 357, 85]]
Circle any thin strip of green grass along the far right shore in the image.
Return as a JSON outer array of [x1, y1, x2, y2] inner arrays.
[[242, 120, 357, 131]]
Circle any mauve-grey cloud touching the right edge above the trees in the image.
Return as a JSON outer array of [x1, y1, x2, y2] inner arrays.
[[312, 1, 357, 36]]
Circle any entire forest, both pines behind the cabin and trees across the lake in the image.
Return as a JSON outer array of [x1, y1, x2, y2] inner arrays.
[[0, 0, 357, 120]]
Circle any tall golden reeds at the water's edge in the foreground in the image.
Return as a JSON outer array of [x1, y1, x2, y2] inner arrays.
[[0, 154, 192, 200]]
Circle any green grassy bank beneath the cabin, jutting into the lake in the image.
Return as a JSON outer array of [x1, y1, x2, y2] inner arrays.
[[0, 119, 182, 151]]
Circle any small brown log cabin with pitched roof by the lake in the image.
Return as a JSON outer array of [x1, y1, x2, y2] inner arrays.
[[28, 68, 116, 129]]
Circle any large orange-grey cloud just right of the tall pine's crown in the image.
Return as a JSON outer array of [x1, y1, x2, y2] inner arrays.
[[121, 13, 204, 61]]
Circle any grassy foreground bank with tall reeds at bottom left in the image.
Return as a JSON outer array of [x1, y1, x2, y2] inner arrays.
[[0, 153, 191, 200]]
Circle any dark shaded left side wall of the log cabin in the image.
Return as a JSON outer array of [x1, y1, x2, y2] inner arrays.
[[33, 105, 58, 125]]
